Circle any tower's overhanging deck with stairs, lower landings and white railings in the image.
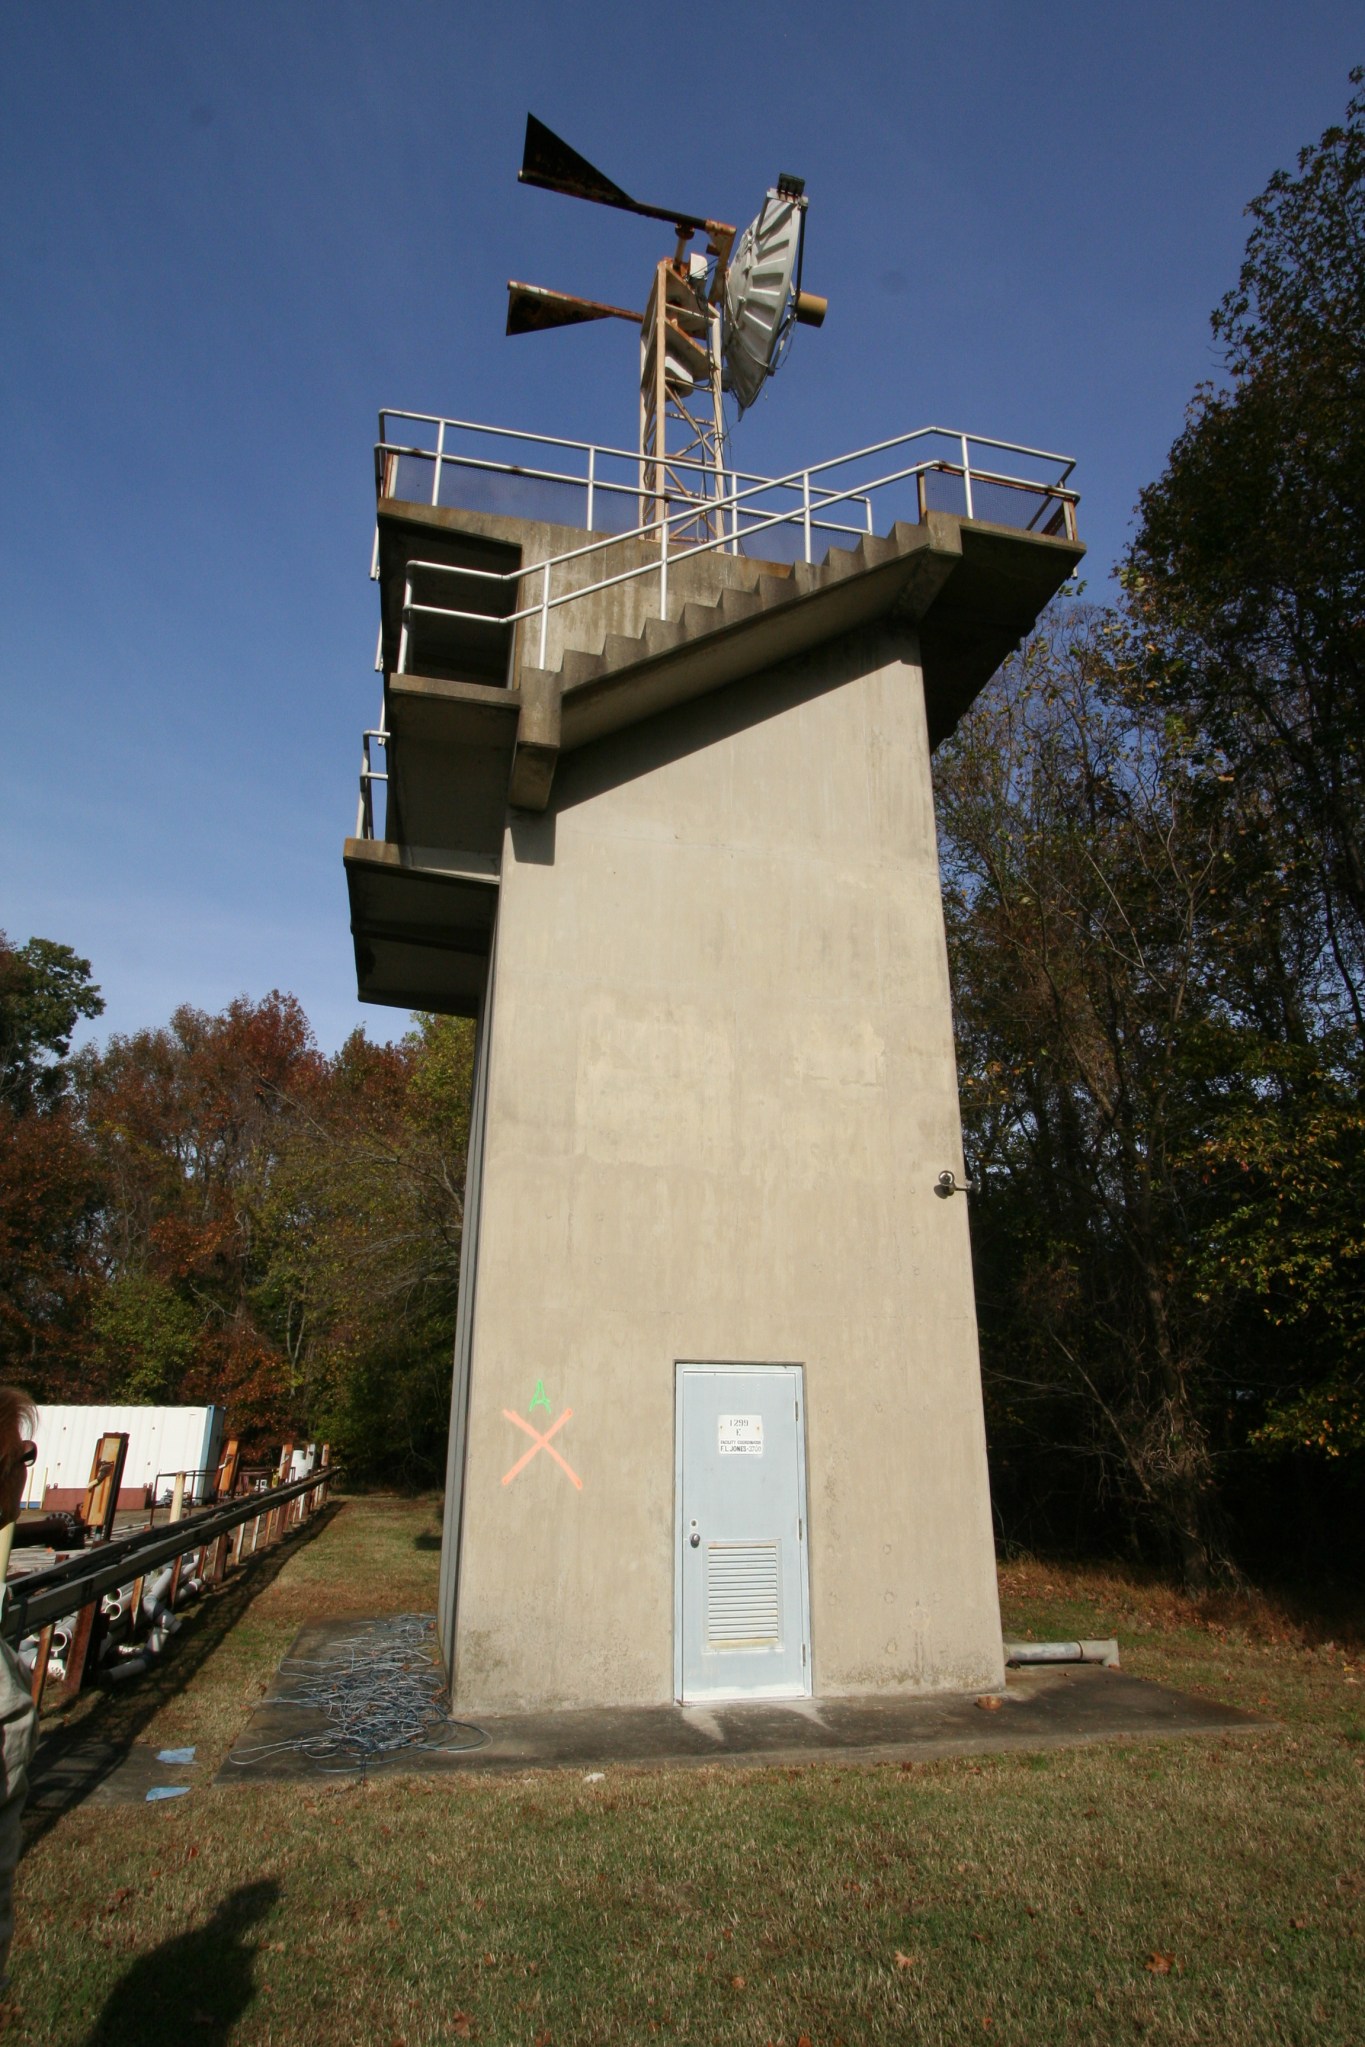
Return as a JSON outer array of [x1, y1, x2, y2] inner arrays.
[[344, 411, 1085, 1015]]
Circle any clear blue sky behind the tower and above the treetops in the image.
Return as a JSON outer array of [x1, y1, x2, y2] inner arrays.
[[0, 0, 1365, 1048]]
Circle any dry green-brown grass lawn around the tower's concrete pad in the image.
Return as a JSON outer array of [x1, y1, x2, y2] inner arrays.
[[2, 1498, 1365, 2047]]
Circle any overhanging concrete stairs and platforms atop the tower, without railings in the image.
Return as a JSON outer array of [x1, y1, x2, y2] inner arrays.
[[346, 499, 1085, 1013]]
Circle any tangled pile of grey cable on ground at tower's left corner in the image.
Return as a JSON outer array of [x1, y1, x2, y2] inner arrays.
[[231, 1613, 489, 1771]]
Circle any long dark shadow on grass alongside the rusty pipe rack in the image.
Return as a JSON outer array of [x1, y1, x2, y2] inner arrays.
[[25, 1500, 344, 1853]]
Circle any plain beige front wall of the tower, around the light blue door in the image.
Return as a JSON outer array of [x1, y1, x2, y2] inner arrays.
[[446, 614, 1001, 1711]]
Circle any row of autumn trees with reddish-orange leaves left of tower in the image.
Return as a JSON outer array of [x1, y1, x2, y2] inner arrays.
[[0, 940, 473, 1482]]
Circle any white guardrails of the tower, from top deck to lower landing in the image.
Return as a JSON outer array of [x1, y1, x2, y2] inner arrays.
[[356, 409, 1081, 837]]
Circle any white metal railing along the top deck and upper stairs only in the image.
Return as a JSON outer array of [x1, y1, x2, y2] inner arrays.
[[375, 411, 1081, 673]]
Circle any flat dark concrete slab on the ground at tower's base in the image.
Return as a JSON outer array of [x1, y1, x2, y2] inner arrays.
[[217, 1621, 1267, 1783]]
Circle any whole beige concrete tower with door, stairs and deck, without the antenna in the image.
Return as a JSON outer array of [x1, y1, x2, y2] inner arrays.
[[346, 427, 1083, 1711]]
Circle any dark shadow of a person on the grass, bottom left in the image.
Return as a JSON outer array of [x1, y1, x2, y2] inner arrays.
[[82, 1877, 280, 2047]]
